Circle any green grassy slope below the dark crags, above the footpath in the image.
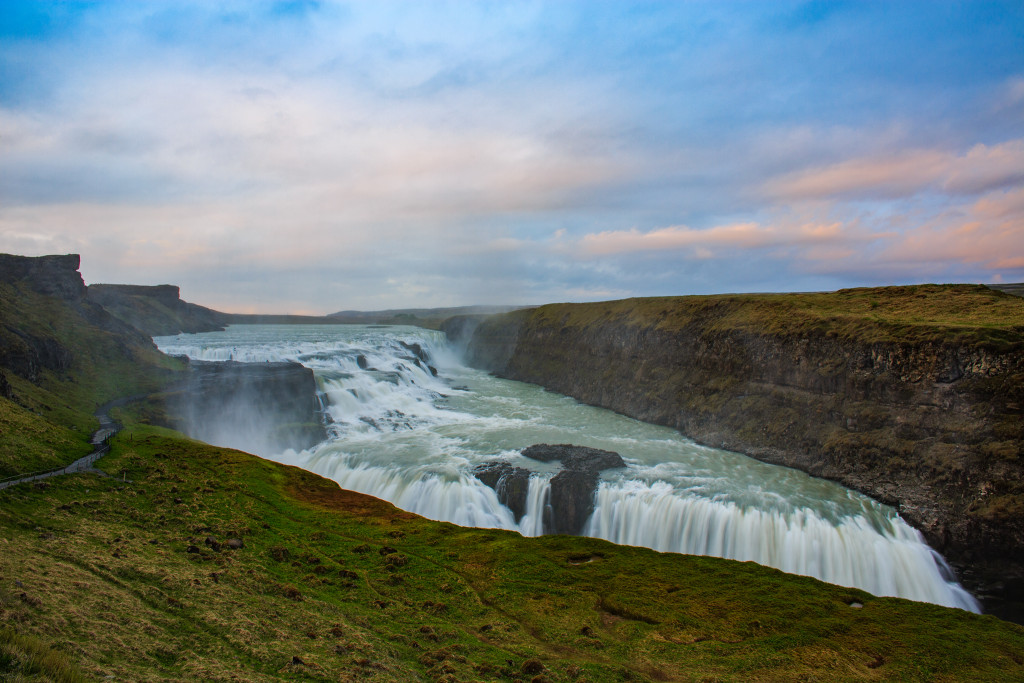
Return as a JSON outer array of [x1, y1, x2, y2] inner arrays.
[[0, 284, 180, 477]]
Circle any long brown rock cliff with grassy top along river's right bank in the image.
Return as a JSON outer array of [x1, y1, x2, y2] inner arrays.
[[467, 286, 1024, 618]]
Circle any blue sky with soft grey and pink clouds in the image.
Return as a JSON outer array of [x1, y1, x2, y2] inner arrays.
[[0, 0, 1024, 313]]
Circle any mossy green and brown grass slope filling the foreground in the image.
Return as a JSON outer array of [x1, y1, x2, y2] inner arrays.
[[0, 425, 1024, 682]]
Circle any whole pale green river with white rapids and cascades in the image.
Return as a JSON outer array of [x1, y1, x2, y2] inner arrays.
[[156, 326, 978, 611]]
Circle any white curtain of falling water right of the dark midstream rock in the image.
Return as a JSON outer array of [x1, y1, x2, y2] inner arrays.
[[584, 481, 978, 611]]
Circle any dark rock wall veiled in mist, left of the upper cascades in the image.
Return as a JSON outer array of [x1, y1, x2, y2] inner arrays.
[[167, 360, 327, 456]]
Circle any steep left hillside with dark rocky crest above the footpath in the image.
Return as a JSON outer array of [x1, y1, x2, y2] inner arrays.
[[0, 254, 180, 476]]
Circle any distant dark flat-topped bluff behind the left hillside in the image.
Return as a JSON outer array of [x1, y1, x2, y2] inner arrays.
[[88, 285, 228, 337]]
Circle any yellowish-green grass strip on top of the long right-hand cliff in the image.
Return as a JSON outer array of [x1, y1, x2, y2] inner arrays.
[[524, 285, 1024, 347]]
